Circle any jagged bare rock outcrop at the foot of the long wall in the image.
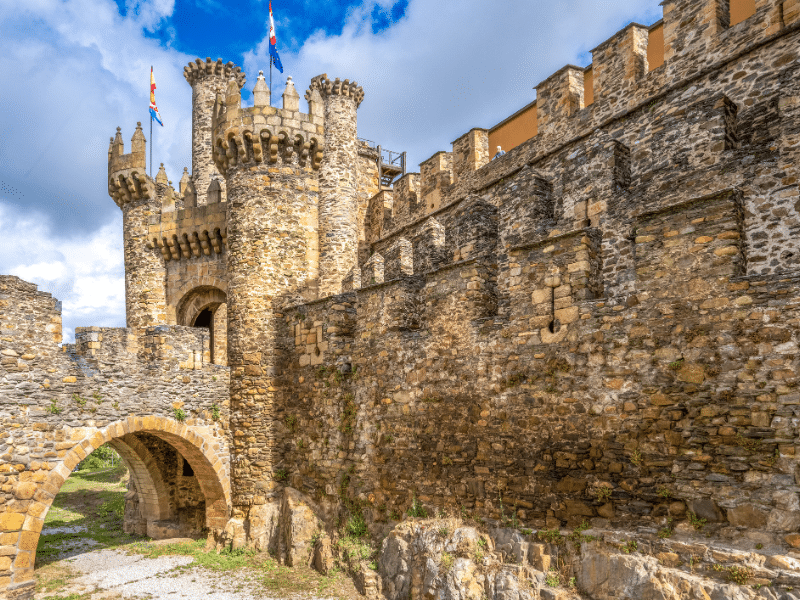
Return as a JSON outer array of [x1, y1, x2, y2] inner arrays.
[[377, 520, 800, 600]]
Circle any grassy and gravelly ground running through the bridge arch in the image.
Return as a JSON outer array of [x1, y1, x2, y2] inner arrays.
[[35, 468, 362, 600]]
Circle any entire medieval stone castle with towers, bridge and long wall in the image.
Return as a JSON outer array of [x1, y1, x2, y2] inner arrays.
[[0, 0, 800, 600]]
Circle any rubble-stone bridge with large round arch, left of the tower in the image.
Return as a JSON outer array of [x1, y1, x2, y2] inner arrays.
[[0, 276, 231, 600]]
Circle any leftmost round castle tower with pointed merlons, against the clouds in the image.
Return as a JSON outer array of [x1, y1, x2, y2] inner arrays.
[[108, 123, 167, 329]]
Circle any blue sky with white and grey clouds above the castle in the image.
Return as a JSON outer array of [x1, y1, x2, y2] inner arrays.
[[0, 0, 661, 340]]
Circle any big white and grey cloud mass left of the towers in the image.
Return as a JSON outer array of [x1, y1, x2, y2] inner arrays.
[[0, 0, 193, 341]]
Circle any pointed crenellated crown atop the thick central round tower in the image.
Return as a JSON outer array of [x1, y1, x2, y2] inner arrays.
[[213, 73, 325, 172]]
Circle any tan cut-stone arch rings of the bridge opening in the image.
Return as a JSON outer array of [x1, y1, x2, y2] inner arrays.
[[7, 416, 231, 598]]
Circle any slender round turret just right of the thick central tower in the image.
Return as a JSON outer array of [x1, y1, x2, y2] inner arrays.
[[306, 75, 364, 297]]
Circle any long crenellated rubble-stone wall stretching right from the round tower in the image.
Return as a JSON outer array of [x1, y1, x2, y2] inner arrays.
[[266, 2, 800, 534]]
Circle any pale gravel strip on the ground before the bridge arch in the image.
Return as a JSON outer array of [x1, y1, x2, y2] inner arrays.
[[36, 550, 288, 600]]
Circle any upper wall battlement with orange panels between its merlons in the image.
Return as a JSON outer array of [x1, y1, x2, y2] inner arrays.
[[478, 0, 800, 160]]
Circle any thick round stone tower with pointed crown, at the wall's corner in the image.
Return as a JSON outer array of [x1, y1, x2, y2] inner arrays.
[[213, 78, 324, 510]]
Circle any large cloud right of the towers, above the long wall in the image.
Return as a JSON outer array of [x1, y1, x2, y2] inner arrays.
[[245, 0, 661, 169]]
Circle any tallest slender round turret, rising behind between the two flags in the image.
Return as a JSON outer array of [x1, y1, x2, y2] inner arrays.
[[183, 58, 247, 206]]
